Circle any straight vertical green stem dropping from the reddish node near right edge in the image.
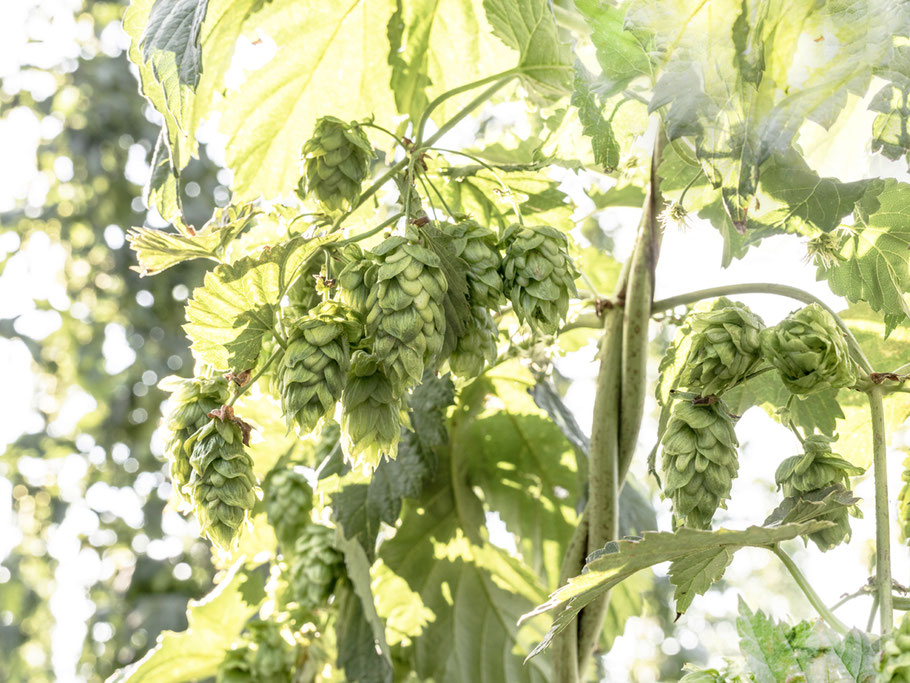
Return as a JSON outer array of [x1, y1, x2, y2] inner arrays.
[[868, 386, 894, 635]]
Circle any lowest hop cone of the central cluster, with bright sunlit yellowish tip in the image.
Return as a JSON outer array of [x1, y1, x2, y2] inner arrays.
[[341, 351, 402, 467]]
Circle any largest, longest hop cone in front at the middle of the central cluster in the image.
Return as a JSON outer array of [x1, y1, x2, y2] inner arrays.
[[366, 237, 447, 395]]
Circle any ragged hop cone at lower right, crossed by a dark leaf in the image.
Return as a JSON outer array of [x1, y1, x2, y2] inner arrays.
[[774, 434, 864, 551]]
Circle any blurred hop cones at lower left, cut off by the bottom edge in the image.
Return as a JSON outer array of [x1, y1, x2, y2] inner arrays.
[[217, 620, 294, 683]]
